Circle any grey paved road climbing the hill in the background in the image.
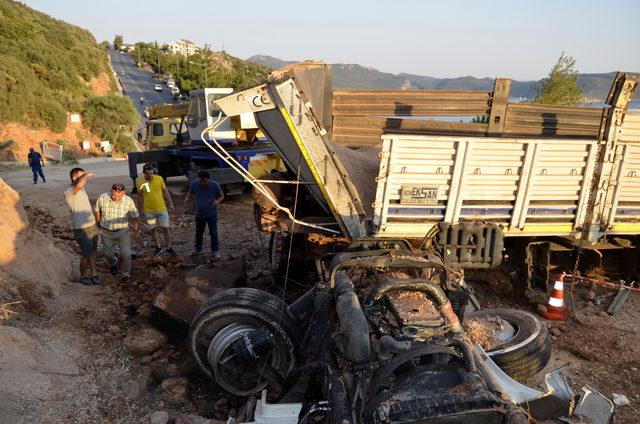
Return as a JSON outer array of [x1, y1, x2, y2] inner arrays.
[[109, 49, 175, 117]]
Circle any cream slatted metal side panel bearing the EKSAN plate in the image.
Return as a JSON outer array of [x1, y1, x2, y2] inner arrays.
[[373, 135, 598, 238]]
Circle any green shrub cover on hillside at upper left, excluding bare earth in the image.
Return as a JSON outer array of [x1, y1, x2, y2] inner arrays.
[[0, 0, 111, 132]]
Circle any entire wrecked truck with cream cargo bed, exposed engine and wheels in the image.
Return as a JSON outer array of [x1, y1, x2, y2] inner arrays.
[[189, 62, 640, 424]]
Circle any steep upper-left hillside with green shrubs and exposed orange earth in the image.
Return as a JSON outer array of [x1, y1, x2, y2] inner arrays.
[[0, 0, 139, 160]]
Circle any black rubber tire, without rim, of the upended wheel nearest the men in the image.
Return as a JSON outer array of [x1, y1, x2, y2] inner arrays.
[[189, 287, 299, 396]]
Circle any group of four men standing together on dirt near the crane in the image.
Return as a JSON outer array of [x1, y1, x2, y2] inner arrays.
[[64, 164, 224, 285]]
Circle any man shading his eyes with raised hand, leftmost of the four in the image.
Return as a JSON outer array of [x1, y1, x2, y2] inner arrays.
[[64, 168, 100, 285]]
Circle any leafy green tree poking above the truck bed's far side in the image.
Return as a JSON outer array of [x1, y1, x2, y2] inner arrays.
[[532, 52, 585, 106]]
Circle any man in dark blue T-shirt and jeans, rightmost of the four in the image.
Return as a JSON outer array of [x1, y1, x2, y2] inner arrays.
[[184, 170, 224, 259]]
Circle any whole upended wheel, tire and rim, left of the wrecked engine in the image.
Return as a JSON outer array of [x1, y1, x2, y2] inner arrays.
[[189, 287, 298, 396]]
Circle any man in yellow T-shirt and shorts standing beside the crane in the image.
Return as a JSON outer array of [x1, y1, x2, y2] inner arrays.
[[136, 163, 177, 256]]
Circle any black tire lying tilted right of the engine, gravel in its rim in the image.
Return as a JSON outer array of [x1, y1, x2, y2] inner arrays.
[[465, 309, 551, 382]]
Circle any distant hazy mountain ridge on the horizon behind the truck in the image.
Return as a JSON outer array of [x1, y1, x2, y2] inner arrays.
[[247, 55, 638, 100]]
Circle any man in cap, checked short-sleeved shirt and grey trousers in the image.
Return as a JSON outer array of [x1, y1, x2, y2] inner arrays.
[[94, 183, 140, 283]]
